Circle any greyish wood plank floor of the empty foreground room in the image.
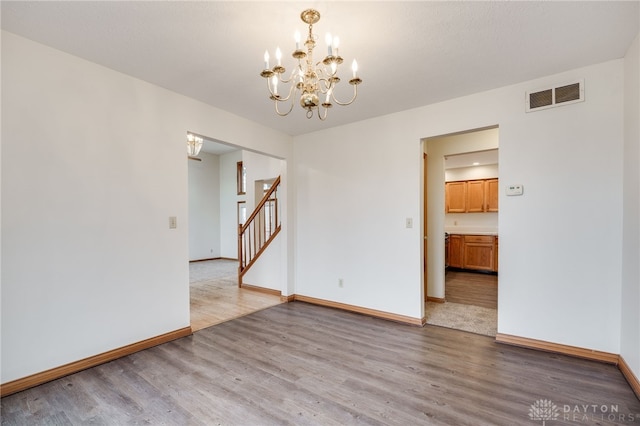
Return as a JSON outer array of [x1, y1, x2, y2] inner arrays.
[[1, 302, 640, 426]]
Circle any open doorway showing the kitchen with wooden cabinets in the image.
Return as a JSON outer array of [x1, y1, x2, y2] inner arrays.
[[423, 126, 499, 336]]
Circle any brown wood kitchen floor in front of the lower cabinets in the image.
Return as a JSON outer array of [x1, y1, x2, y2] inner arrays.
[[445, 270, 498, 309]]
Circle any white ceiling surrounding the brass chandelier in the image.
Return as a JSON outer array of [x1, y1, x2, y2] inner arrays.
[[1, 1, 640, 135]]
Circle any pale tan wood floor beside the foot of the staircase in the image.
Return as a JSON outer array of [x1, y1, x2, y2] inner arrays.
[[189, 260, 282, 331]]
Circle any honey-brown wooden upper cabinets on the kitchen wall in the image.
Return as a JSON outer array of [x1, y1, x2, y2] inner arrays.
[[445, 179, 499, 213]]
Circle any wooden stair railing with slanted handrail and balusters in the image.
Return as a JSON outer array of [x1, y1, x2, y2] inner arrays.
[[238, 176, 281, 287]]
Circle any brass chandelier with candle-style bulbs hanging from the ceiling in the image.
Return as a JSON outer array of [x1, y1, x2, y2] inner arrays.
[[260, 9, 362, 120]]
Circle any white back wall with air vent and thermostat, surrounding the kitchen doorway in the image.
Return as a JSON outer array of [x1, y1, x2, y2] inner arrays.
[[294, 60, 623, 353]]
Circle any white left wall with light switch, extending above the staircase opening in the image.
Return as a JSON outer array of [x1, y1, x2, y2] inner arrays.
[[1, 31, 292, 383]]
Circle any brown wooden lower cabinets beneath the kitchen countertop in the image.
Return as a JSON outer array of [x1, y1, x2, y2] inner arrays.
[[449, 235, 498, 272]]
